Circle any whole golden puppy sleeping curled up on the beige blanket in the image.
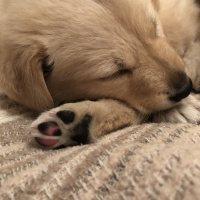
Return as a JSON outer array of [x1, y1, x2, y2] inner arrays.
[[0, 0, 200, 148]]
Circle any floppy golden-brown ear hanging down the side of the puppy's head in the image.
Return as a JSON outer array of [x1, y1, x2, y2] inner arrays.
[[0, 46, 54, 111]]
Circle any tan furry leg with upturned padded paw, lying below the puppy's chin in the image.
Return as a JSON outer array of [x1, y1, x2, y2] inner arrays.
[[31, 99, 144, 148]]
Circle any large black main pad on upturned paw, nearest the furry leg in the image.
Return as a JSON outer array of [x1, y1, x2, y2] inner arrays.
[[71, 115, 92, 144]]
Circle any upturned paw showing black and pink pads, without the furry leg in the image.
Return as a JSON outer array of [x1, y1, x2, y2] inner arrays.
[[31, 107, 92, 148]]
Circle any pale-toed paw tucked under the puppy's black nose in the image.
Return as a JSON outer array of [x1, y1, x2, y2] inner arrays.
[[152, 95, 200, 124]]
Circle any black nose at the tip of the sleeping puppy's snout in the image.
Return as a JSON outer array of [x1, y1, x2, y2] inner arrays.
[[169, 75, 192, 102]]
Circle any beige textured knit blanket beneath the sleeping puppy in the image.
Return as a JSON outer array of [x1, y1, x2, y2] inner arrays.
[[0, 96, 200, 200]]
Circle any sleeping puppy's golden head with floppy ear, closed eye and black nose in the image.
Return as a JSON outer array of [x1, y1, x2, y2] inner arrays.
[[0, 0, 191, 113]]
